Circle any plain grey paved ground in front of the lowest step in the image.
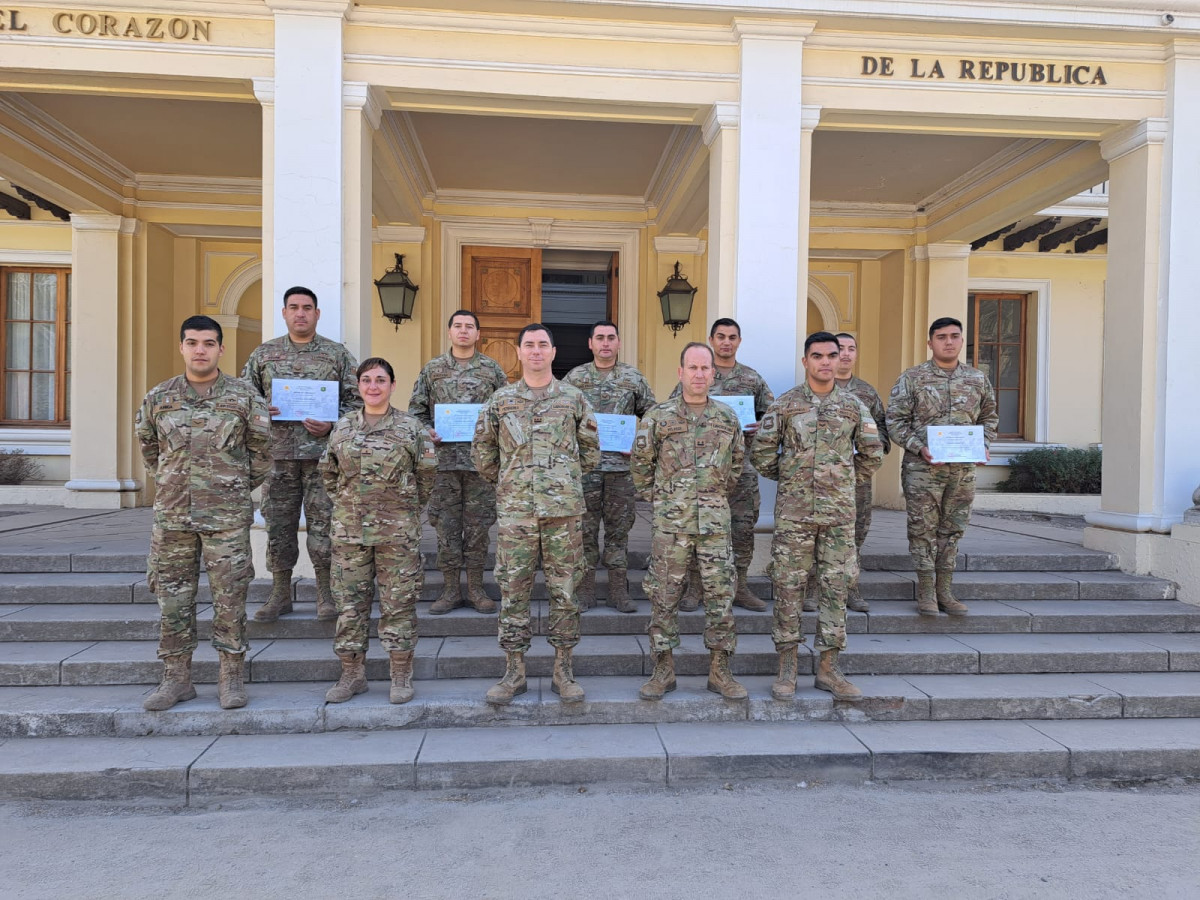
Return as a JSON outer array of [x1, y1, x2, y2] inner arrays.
[[0, 782, 1200, 900]]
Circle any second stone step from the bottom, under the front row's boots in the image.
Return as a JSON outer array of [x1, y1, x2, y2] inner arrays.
[[7, 672, 1200, 738]]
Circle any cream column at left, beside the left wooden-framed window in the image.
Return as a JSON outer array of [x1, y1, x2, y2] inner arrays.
[[66, 215, 142, 509]]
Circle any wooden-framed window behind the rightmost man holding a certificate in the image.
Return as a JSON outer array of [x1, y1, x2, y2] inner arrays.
[[966, 293, 1028, 439]]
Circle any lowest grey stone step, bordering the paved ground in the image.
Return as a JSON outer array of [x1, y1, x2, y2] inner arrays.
[[0, 719, 1200, 806]]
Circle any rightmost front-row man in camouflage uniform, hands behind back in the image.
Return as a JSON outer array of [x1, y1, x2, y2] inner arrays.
[[750, 331, 883, 700]]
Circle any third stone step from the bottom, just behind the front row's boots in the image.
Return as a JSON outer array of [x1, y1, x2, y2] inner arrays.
[[9, 632, 1200, 685]]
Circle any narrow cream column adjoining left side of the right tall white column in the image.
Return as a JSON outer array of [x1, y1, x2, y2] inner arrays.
[[702, 103, 738, 326]]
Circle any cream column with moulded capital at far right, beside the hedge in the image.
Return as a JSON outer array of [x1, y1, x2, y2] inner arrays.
[[1087, 119, 1171, 532]]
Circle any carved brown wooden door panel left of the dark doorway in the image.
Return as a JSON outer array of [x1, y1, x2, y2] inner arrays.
[[462, 247, 541, 382]]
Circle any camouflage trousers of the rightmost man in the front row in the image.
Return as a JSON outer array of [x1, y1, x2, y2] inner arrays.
[[770, 520, 858, 650]]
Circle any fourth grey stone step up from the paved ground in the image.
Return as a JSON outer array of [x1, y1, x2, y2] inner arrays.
[[0, 600, 1200, 643]]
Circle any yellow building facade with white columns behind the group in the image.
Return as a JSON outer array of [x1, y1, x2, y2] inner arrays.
[[0, 0, 1200, 592]]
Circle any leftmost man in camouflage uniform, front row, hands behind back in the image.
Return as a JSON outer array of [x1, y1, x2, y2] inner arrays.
[[137, 316, 271, 710]]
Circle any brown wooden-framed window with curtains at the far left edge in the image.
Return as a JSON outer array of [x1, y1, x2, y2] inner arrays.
[[0, 268, 71, 425]]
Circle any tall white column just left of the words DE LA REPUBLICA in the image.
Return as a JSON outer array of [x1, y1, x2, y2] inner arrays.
[[734, 19, 812, 395]]
